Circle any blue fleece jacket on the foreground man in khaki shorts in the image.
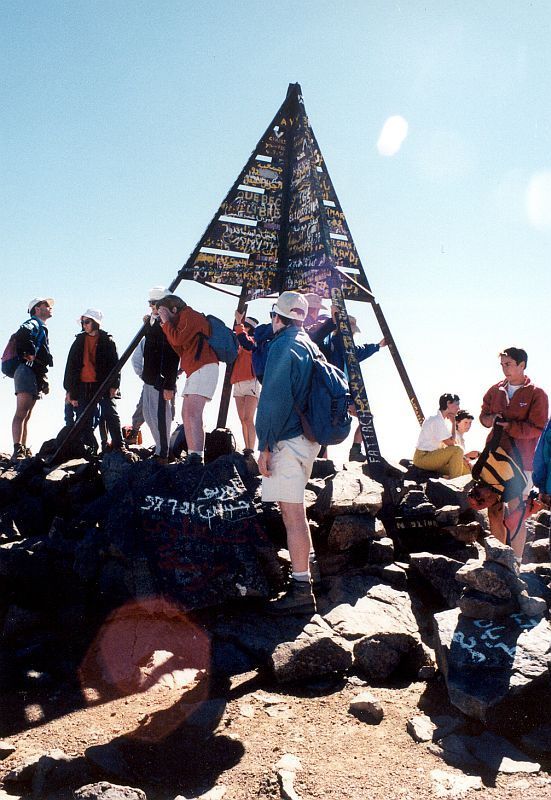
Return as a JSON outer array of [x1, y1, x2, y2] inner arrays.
[[256, 325, 313, 451]]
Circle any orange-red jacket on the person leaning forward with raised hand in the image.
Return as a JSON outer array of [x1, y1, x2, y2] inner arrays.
[[162, 306, 218, 378]]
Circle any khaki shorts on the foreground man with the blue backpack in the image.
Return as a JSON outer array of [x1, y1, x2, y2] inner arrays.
[[262, 435, 320, 503]]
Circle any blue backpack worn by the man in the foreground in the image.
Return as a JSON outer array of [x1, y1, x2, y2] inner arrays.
[[296, 340, 352, 447]]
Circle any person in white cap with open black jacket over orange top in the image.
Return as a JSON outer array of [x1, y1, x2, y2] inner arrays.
[[63, 308, 122, 452]]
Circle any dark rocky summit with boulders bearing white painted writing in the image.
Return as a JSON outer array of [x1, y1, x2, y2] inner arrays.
[[0, 447, 551, 798]]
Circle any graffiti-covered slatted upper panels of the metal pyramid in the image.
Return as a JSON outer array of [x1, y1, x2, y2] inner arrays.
[[181, 85, 374, 300]]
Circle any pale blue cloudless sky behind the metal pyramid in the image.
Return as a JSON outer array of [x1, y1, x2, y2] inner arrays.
[[0, 0, 551, 461]]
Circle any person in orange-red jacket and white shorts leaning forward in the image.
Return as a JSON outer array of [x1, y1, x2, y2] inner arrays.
[[157, 294, 219, 465]]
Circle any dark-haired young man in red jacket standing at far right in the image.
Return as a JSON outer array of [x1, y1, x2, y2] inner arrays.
[[480, 347, 549, 562]]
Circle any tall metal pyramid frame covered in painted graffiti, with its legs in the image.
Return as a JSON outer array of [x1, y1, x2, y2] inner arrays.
[[52, 83, 424, 478]]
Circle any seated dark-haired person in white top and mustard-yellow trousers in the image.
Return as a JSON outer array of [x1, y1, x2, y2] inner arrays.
[[413, 392, 469, 478]]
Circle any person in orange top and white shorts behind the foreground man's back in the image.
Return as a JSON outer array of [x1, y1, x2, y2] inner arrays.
[[230, 311, 260, 456]]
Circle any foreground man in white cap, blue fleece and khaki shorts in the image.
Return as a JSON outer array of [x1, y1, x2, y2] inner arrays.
[[256, 292, 320, 615]]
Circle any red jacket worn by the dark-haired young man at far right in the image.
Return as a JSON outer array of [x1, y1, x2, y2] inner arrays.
[[480, 377, 549, 470]]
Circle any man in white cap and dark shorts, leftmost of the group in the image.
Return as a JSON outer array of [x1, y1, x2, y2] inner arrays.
[[12, 297, 54, 462]]
